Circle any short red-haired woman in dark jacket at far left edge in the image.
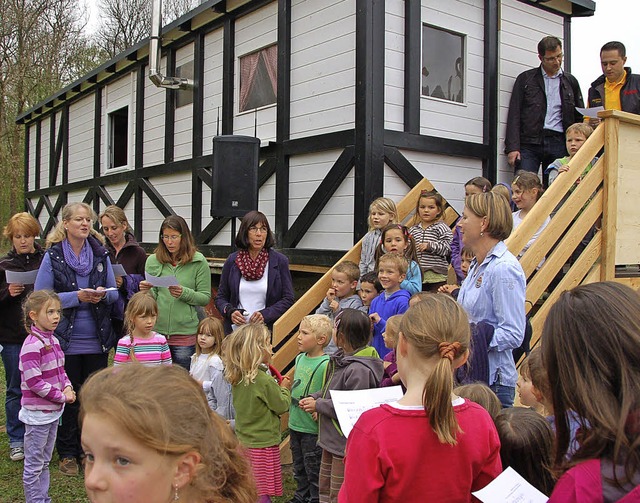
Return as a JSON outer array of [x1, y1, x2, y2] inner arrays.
[[0, 213, 44, 461]]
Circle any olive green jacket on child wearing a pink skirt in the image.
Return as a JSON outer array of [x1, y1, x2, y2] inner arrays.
[[232, 365, 291, 448]]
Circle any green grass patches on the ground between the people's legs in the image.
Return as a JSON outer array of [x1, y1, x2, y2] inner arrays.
[[0, 361, 295, 503]]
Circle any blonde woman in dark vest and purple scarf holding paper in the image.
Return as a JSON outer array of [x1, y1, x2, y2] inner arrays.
[[35, 203, 118, 475]]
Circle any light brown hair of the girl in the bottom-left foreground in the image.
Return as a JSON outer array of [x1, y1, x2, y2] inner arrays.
[[80, 365, 258, 503]]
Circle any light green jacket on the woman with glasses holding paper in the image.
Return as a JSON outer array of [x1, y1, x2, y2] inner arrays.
[[144, 252, 211, 338]]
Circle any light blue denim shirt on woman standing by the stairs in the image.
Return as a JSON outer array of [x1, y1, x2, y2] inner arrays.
[[458, 241, 526, 387]]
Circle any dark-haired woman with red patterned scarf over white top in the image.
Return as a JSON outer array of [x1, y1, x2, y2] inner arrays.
[[216, 211, 293, 334]]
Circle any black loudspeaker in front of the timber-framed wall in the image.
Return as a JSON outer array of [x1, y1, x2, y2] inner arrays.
[[211, 135, 260, 217]]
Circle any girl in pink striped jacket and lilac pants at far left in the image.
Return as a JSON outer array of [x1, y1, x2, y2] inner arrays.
[[18, 290, 76, 502]]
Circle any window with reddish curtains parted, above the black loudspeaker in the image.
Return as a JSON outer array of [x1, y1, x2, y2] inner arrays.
[[239, 44, 278, 112]]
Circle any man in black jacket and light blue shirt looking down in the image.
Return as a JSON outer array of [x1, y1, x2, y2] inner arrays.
[[505, 37, 584, 187]]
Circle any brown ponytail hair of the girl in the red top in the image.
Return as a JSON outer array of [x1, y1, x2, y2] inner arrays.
[[400, 294, 471, 445]]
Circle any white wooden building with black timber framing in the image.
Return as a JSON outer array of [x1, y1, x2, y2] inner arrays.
[[18, 0, 595, 266]]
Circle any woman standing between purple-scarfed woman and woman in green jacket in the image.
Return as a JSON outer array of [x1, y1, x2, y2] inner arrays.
[[100, 205, 147, 335]]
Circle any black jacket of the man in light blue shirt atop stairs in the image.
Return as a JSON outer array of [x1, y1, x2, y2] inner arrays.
[[505, 66, 584, 154]]
